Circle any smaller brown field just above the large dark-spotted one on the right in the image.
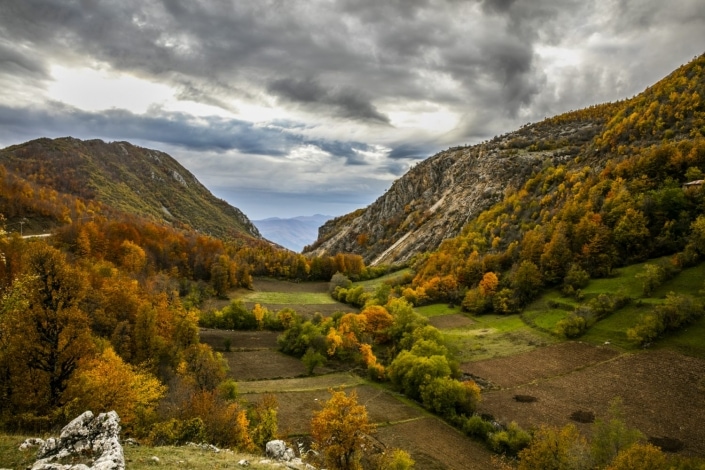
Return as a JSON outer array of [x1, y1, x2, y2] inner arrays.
[[460, 342, 619, 388]]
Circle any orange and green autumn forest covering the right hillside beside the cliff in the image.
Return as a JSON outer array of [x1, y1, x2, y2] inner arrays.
[[414, 56, 705, 311]]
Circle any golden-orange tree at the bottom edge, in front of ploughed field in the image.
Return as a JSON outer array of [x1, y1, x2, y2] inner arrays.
[[311, 390, 375, 470]]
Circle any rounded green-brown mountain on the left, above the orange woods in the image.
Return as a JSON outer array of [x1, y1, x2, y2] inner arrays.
[[0, 137, 260, 238]]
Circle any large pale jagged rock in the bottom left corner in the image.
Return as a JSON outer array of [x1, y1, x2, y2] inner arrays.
[[20, 411, 125, 470]]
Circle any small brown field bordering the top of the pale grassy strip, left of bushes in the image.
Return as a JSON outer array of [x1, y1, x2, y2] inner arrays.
[[222, 349, 307, 380]]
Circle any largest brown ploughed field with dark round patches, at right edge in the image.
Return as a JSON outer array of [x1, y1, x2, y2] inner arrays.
[[480, 351, 705, 457]]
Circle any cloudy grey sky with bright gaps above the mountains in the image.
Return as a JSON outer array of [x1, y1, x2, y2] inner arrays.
[[0, 0, 705, 219]]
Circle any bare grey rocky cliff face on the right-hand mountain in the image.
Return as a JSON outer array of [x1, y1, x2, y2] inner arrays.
[[304, 115, 604, 265]]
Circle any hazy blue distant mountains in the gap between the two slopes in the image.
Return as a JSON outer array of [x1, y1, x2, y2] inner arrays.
[[252, 214, 333, 253]]
